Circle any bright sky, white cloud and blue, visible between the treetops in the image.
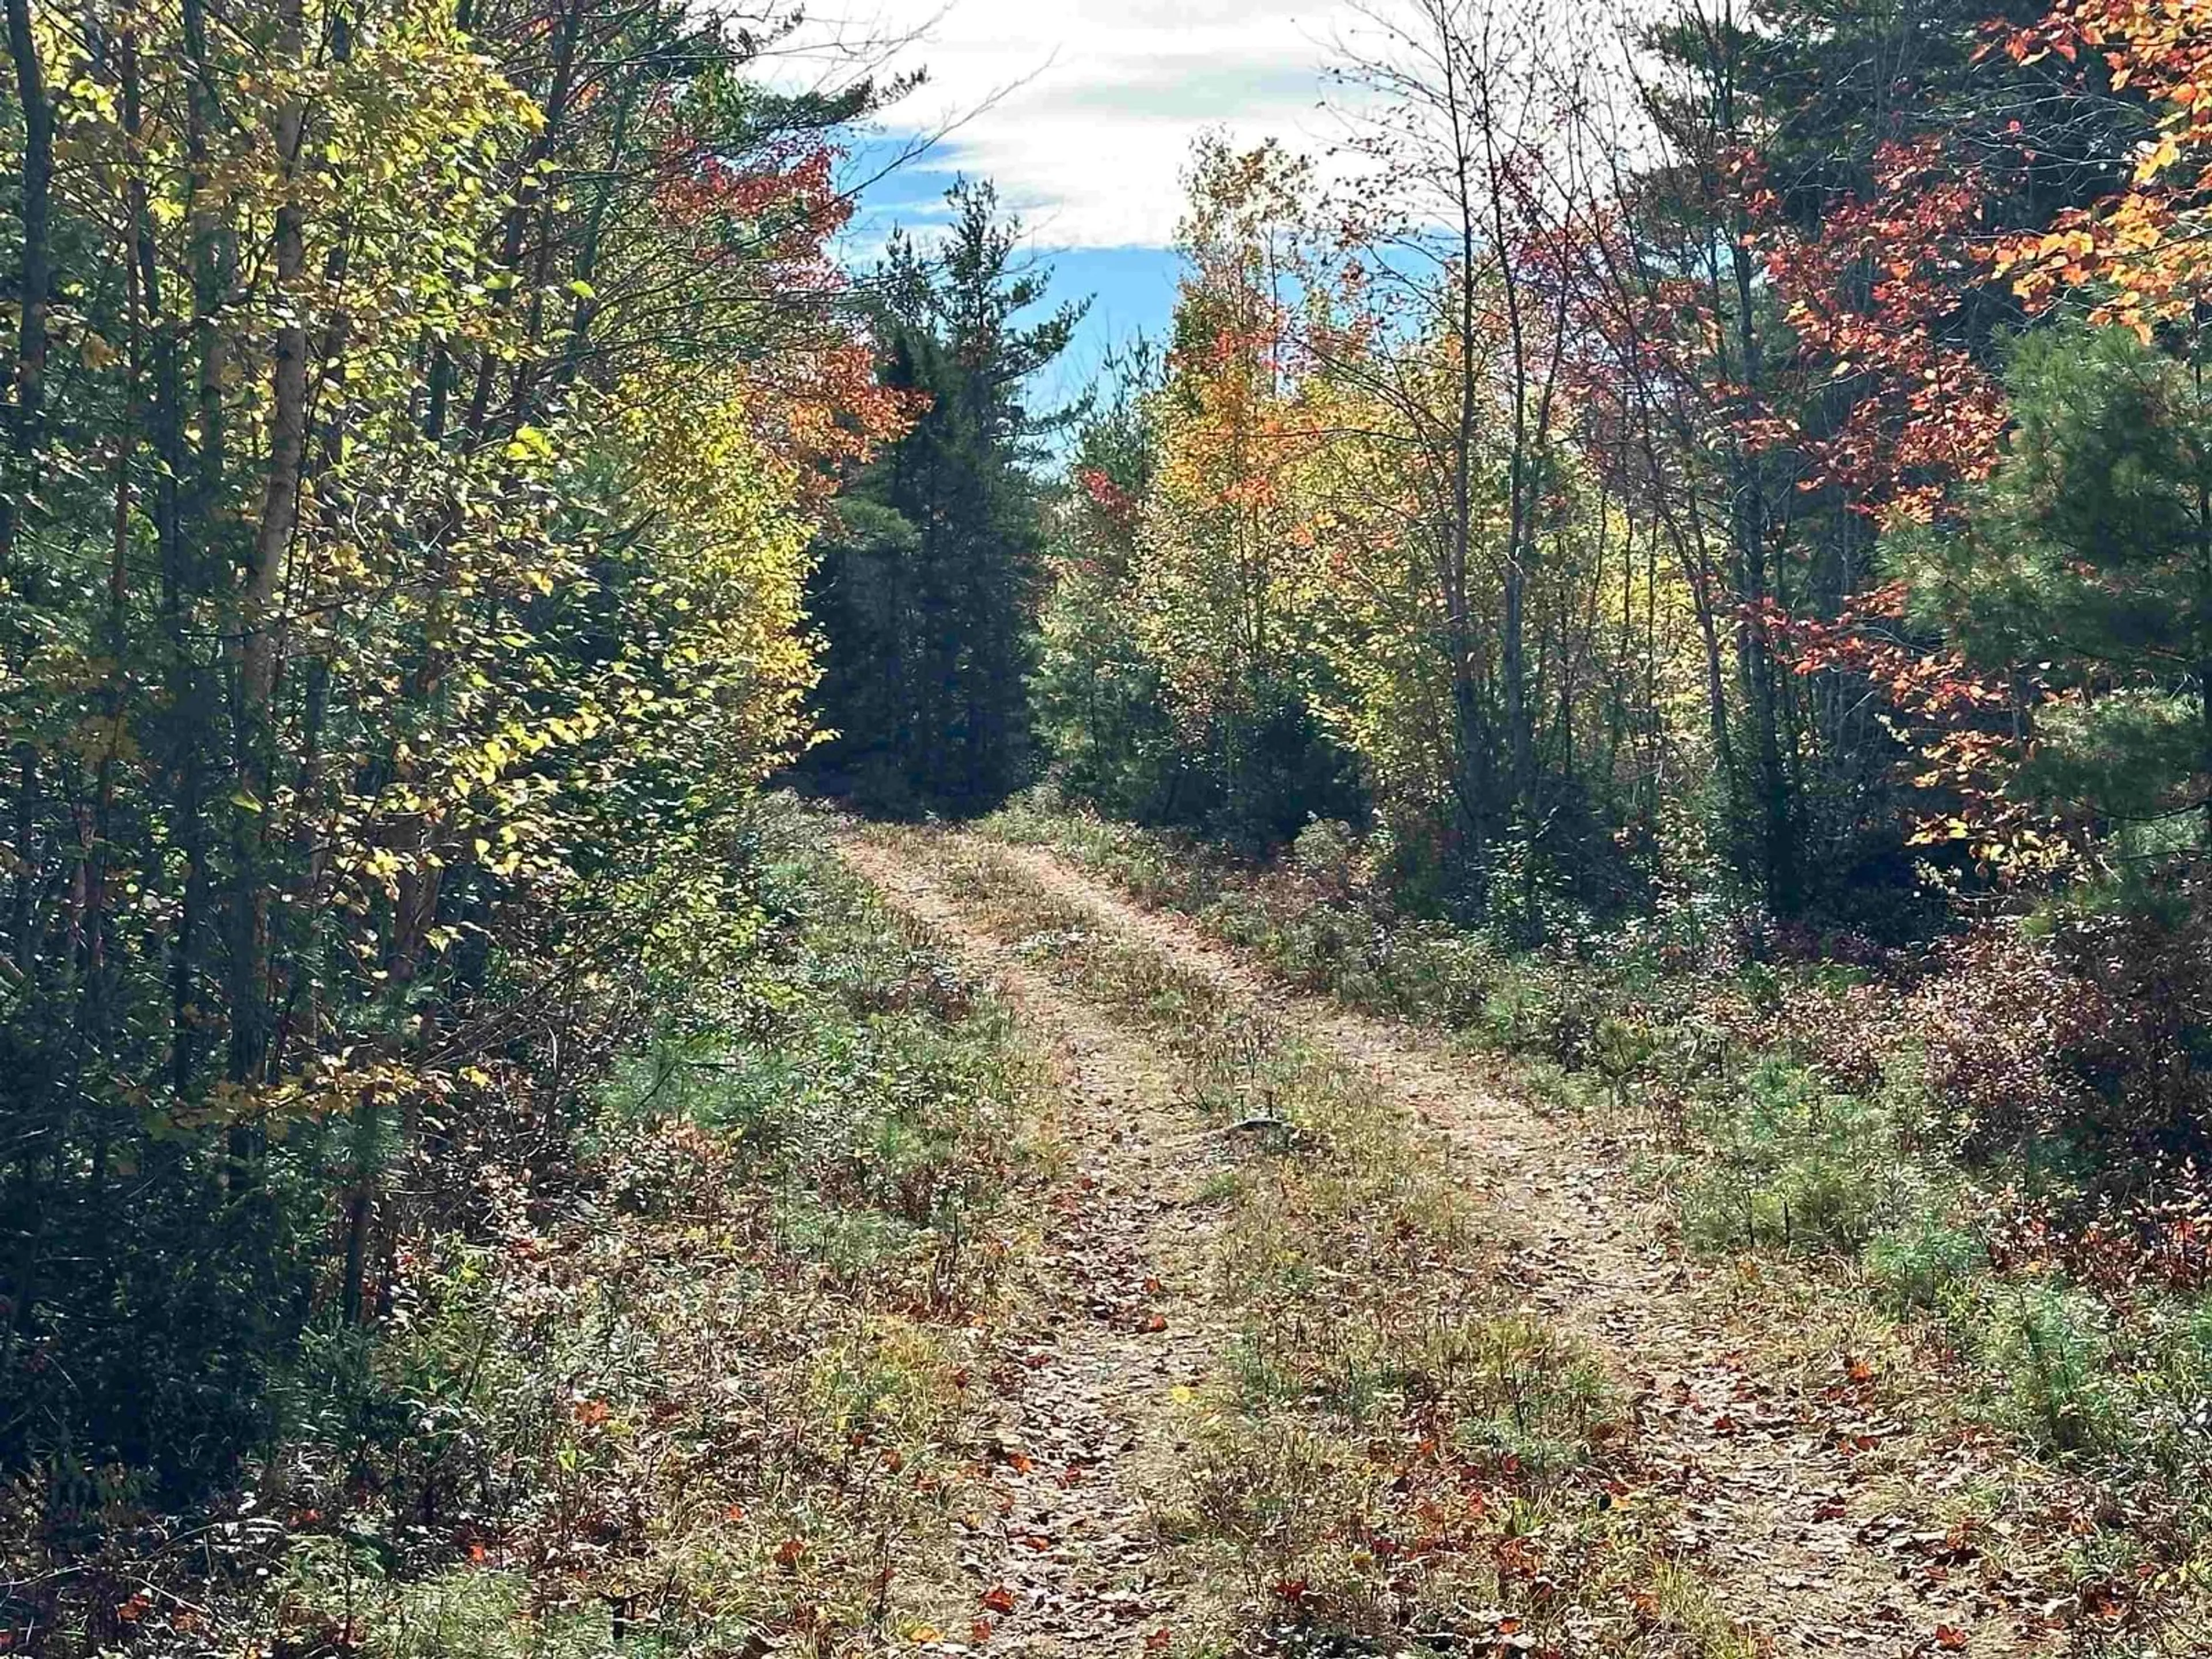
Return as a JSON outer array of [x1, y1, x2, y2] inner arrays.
[[814, 0, 1356, 403]]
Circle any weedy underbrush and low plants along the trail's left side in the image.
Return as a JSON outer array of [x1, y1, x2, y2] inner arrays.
[[0, 801, 1051, 1659]]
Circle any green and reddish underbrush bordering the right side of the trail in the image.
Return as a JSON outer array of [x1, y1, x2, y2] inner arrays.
[[987, 803, 2212, 1650]]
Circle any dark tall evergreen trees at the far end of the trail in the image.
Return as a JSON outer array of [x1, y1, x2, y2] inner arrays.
[[816, 181, 1086, 809]]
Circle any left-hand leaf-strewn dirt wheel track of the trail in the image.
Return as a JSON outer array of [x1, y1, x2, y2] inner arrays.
[[845, 840, 1224, 1657]]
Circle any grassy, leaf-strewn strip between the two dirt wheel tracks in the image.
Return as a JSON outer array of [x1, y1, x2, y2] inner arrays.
[[893, 843, 1749, 1654]]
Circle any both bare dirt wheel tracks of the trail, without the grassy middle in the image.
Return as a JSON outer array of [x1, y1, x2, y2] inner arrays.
[[851, 834, 2037, 1654]]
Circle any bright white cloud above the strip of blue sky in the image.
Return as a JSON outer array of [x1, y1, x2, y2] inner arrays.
[[844, 0, 1347, 248]]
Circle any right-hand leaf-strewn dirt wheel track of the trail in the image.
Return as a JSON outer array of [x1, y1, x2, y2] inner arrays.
[[951, 843, 2039, 1654]]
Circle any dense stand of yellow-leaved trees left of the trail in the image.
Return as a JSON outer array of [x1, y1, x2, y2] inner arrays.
[[0, 0, 896, 1495]]
